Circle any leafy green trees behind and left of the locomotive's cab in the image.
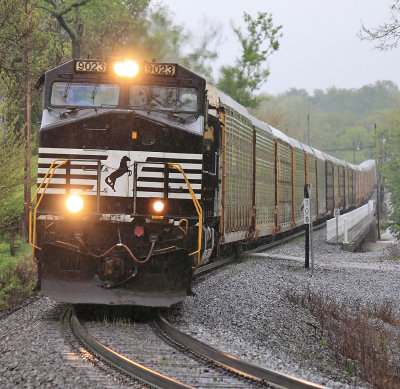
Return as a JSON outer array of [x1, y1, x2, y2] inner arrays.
[[0, 0, 222, 230]]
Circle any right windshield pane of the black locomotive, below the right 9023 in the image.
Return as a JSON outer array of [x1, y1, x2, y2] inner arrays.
[[129, 85, 198, 112]]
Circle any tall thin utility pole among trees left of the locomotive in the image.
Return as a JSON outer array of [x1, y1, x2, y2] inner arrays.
[[24, 0, 32, 237]]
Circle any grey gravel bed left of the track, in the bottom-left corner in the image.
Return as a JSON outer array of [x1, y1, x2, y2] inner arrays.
[[0, 297, 125, 389]]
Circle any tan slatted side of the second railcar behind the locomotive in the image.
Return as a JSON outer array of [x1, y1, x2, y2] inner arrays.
[[255, 128, 275, 236]]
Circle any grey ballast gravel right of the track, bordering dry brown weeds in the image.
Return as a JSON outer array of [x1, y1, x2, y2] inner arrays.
[[169, 229, 400, 388]]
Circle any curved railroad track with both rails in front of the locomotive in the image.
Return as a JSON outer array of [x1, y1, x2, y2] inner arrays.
[[65, 307, 321, 389]]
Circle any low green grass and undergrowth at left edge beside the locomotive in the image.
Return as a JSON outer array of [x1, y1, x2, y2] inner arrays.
[[0, 238, 37, 311]]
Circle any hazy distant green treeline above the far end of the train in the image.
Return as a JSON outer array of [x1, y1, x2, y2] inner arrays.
[[253, 81, 400, 163]]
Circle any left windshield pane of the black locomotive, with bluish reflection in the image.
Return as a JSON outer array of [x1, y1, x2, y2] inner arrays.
[[51, 82, 119, 107]]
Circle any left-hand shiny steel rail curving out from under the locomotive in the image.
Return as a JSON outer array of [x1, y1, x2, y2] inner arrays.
[[66, 308, 193, 389]]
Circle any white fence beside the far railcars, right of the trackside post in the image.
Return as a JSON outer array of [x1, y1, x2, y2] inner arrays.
[[326, 200, 375, 244]]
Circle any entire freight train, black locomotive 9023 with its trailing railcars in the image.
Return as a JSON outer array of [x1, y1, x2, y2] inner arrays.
[[30, 59, 375, 306]]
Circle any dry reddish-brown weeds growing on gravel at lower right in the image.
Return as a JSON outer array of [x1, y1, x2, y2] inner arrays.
[[285, 290, 400, 389]]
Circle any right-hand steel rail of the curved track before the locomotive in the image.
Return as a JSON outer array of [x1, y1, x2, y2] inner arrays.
[[157, 313, 324, 389]]
